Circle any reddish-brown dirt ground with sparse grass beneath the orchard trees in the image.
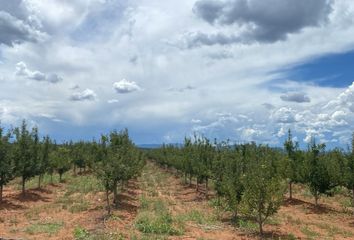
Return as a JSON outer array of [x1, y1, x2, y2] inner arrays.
[[0, 163, 354, 240]]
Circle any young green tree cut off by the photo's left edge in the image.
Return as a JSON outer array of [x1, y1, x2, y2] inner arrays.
[[0, 126, 14, 202]]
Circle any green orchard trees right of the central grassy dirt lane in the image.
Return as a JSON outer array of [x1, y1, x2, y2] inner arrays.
[[148, 130, 354, 234]]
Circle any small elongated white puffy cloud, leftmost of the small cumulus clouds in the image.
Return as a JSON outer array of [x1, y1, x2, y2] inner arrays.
[[15, 62, 63, 83]]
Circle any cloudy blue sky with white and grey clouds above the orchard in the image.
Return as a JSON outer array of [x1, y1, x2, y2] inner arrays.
[[0, 0, 354, 148]]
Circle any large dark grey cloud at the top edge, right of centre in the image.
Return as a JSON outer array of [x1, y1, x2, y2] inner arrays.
[[193, 0, 332, 45]]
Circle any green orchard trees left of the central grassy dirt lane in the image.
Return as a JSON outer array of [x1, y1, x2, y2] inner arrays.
[[0, 121, 145, 213]]
